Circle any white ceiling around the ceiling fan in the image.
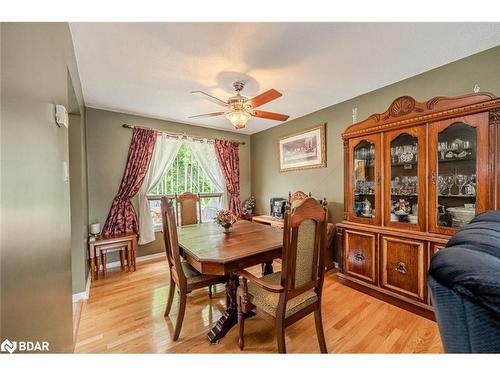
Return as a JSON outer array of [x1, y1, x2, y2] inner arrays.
[[70, 23, 500, 134]]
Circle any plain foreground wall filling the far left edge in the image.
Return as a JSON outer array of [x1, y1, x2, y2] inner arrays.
[[0, 23, 83, 352]]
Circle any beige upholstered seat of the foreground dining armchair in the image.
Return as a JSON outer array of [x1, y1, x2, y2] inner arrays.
[[238, 272, 318, 318]]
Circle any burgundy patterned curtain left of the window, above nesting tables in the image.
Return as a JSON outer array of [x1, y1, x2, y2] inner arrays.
[[103, 128, 157, 235]]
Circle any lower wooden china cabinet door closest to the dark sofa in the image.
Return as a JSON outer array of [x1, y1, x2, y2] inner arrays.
[[380, 236, 426, 301]]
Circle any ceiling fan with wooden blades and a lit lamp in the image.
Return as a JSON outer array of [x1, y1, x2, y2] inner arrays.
[[189, 82, 290, 129]]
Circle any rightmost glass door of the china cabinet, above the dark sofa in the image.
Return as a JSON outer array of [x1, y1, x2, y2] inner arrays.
[[429, 114, 488, 234]]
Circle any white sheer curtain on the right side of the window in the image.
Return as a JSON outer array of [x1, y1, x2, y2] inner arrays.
[[187, 139, 228, 213]]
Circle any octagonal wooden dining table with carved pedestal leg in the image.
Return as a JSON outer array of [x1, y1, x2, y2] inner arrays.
[[177, 220, 283, 343]]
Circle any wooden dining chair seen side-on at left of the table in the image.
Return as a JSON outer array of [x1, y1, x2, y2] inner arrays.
[[161, 197, 226, 341]]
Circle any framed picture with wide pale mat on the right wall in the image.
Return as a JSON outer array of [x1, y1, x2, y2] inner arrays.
[[278, 124, 326, 172]]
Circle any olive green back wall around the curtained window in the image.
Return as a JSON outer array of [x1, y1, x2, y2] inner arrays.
[[86, 108, 250, 260]]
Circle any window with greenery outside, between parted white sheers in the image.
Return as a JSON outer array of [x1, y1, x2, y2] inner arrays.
[[148, 143, 223, 230]]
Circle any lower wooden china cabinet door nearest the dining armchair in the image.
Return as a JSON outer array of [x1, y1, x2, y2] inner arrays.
[[344, 230, 377, 284]]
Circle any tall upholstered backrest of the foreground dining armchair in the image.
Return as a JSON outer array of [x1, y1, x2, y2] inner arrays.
[[281, 197, 328, 299]]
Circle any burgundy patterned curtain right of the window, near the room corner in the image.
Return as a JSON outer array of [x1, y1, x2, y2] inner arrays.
[[214, 139, 241, 216]]
